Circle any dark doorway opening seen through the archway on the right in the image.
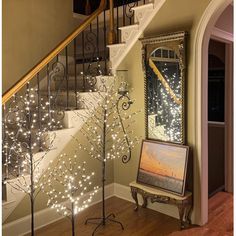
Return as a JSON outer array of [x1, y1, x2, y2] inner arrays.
[[208, 39, 225, 198]]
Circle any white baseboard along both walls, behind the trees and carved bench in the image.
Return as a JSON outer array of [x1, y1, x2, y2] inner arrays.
[[2, 183, 178, 236]]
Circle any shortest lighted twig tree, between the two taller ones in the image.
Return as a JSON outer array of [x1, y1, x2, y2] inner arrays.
[[43, 154, 98, 236]]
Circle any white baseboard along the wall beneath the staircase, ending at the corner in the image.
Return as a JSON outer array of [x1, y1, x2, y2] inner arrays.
[[2, 184, 114, 236]]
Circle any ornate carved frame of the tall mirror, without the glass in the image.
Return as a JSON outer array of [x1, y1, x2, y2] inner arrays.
[[139, 31, 187, 144]]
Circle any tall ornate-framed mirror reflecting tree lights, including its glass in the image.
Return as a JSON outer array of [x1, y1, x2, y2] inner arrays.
[[140, 32, 187, 144]]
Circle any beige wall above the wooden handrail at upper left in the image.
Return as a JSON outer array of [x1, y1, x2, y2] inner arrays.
[[2, 0, 81, 92]]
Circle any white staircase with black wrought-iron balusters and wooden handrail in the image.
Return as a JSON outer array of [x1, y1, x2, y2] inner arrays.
[[2, 0, 165, 227]]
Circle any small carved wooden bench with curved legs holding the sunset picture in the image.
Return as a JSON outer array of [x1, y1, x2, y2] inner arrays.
[[129, 181, 192, 229]]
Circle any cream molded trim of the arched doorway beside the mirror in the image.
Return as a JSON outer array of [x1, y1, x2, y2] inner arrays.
[[194, 0, 232, 225]]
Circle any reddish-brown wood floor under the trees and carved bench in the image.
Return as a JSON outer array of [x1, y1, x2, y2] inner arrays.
[[30, 193, 233, 236]]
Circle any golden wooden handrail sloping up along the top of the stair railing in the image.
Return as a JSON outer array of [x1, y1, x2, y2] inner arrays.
[[2, 0, 107, 104]]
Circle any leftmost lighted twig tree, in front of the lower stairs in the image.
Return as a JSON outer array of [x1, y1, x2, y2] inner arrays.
[[3, 84, 61, 235]]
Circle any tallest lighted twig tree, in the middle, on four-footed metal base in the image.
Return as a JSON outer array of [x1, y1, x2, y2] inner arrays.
[[75, 77, 139, 235]]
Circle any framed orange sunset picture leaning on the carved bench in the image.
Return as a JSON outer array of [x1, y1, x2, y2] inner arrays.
[[137, 140, 189, 196]]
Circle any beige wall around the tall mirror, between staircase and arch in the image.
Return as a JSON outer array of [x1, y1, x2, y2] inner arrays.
[[114, 0, 210, 224]]
